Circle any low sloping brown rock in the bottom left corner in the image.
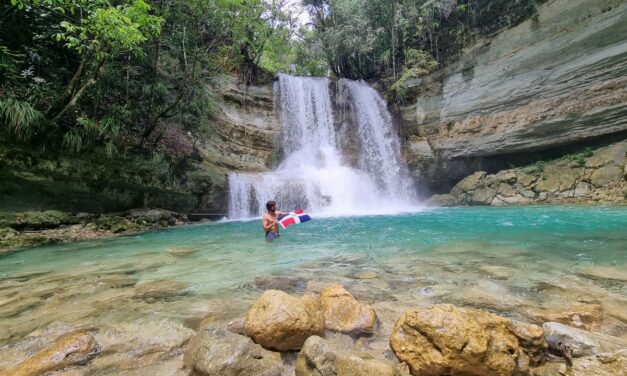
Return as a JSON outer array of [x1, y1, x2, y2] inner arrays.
[[0, 332, 99, 376]]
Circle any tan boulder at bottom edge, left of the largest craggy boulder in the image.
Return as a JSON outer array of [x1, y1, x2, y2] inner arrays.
[[296, 336, 402, 376]]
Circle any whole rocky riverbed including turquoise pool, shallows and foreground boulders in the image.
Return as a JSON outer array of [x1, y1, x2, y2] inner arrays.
[[0, 207, 627, 376]]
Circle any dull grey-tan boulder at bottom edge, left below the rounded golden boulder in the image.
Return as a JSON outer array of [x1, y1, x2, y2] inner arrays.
[[184, 327, 285, 376]]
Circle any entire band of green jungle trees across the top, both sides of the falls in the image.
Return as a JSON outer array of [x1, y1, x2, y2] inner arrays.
[[0, 0, 540, 157]]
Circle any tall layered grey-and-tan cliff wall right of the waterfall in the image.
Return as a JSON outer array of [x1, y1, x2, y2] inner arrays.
[[400, 0, 627, 192]]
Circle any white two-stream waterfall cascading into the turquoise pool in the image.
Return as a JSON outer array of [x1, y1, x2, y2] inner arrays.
[[229, 74, 414, 218]]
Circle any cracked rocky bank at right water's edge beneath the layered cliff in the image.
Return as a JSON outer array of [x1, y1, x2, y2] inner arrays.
[[442, 141, 627, 206]]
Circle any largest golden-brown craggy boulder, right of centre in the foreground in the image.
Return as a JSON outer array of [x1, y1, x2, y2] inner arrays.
[[390, 304, 547, 375]]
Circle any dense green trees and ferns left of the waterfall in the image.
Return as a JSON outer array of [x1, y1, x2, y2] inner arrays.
[[0, 0, 304, 157]]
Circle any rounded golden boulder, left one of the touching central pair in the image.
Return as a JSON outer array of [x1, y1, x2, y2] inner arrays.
[[244, 290, 324, 351]]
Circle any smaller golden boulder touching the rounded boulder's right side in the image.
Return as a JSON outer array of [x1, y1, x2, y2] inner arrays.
[[320, 285, 377, 334]]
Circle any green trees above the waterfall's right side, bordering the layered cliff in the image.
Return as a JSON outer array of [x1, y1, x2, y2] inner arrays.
[[303, 0, 540, 100]]
